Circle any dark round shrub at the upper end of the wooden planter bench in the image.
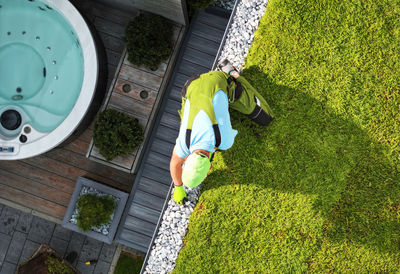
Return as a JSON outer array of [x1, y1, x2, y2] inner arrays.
[[124, 14, 173, 70]]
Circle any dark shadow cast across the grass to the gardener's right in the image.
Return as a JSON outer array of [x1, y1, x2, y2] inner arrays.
[[204, 67, 400, 253]]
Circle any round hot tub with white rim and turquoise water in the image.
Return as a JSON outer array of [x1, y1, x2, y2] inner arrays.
[[0, 0, 98, 160]]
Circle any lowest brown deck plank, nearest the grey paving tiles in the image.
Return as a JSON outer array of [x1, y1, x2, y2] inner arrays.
[[0, 184, 67, 220]]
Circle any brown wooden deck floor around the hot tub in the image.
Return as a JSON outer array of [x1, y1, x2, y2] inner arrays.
[[0, 0, 134, 222]]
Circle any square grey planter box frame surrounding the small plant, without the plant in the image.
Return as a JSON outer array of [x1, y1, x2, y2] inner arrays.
[[61, 177, 128, 244]]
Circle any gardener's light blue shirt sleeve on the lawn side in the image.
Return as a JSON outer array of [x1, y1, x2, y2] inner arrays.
[[213, 90, 238, 150]]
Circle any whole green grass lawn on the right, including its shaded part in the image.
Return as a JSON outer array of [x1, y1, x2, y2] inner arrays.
[[175, 0, 400, 273]]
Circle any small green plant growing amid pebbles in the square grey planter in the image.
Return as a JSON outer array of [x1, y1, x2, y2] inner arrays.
[[77, 193, 116, 232]]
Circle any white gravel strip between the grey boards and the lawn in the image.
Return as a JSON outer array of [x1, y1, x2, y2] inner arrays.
[[144, 0, 268, 273]]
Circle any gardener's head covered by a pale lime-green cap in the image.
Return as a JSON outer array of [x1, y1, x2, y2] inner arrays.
[[182, 150, 211, 188]]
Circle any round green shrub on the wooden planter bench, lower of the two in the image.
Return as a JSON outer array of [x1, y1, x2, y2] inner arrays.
[[93, 109, 143, 161]]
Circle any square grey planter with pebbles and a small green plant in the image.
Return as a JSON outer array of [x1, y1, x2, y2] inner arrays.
[[62, 177, 128, 244]]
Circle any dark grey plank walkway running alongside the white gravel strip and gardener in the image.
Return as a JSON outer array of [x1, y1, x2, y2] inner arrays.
[[117, 7, 228, 252]]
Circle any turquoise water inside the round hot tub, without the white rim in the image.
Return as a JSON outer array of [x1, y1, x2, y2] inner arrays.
[[0, 0, 84, 136]]
